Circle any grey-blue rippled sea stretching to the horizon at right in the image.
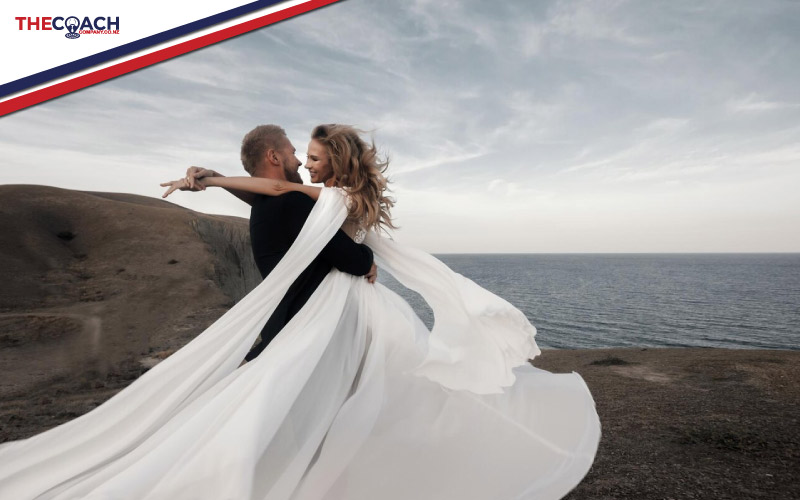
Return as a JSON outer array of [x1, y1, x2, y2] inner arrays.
[[379, 253, 800, 349]]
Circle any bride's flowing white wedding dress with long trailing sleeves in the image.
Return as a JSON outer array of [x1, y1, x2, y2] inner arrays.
[[0, 189, 600, 500]]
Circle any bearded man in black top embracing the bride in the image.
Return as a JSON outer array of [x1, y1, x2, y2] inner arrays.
[[186, 125, 376, 361]]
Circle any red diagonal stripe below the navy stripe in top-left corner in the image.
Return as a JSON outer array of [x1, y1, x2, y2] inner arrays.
[[0, 0, 339, 116]]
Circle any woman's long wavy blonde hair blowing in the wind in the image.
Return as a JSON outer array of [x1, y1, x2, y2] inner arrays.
[[311, 124, 395, 231]]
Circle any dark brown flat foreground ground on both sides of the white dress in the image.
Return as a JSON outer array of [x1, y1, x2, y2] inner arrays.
[[0, 347, 800, 500]]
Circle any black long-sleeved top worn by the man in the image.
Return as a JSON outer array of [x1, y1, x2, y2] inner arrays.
[[245, 192, 373, 361]]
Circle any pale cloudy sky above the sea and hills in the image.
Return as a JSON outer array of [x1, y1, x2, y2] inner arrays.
[[0, 0, 800, 253]]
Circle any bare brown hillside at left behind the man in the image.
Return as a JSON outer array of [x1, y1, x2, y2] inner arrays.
[[0, 185, 260, 401]]
